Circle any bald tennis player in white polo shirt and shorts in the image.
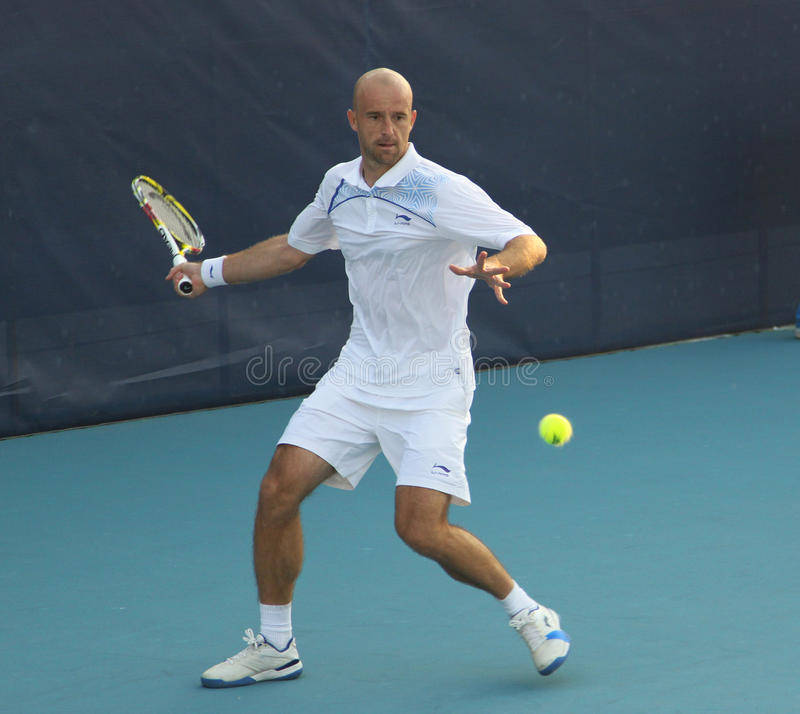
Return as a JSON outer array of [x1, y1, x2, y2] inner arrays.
[[167, 68, 570, 687]]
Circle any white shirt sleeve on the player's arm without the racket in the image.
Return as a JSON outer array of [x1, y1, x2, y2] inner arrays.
[[436, 176, 536, 250]]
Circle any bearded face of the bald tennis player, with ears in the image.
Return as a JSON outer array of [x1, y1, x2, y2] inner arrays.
[[347, 81, 417, 174]]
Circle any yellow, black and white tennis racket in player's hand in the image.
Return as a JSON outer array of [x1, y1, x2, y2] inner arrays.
[[131, 176, 206, 295]]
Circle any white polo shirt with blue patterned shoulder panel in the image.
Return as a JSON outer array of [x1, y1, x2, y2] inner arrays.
[[289, 144, 533, 408]]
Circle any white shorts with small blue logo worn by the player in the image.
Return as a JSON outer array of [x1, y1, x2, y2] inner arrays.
[[278, 378, 472, 506]]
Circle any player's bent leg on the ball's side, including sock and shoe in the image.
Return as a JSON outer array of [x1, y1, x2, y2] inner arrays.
[[395, 486, 569, 675]]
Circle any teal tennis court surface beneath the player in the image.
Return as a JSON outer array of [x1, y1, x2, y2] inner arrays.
[[0, 329, 800, 714]]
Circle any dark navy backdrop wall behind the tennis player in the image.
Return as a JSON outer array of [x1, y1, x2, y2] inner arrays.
[[0, 0, 800, 435]]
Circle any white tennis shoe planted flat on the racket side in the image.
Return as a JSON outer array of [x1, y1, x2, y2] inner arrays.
[[200, 629, 303, 689]]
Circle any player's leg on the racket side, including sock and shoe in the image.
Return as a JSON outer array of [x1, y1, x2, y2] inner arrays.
[[201, 444, 334, 688]]
